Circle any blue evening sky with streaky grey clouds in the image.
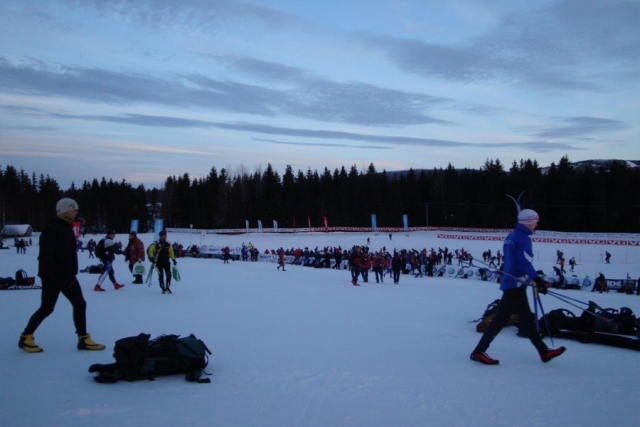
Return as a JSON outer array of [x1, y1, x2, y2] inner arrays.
[[0, 0, 640, 189]]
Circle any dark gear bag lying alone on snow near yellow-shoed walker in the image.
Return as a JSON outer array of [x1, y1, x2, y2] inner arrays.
[[89, 333, 211, 383]]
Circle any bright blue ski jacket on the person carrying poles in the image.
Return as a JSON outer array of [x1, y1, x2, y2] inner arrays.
[[500, 224, 538, 291]]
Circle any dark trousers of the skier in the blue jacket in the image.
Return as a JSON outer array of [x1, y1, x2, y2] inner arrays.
[[474, 286, 548, 354]]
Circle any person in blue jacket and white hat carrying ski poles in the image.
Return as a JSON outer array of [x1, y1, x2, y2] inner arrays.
[[470, 209, 566, 365]]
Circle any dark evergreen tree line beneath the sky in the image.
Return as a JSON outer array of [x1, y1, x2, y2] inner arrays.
[[0, 156, 640, 233]]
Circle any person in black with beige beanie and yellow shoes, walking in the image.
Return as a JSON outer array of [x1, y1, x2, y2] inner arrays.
[[18, 198, 105, 353]]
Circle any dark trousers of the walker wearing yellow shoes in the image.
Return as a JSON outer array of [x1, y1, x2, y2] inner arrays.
[[23, 278, 87, 335]]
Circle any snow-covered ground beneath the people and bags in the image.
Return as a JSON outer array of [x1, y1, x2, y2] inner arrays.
[[0, 232, 640, 427]]
